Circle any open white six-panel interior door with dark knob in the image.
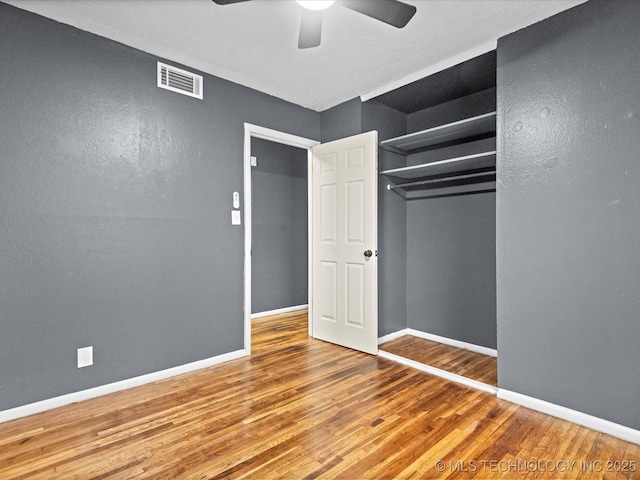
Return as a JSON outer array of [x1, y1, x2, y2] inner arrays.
[[310, 131, 378, 354]]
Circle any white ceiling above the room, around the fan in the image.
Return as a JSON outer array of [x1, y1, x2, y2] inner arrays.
[[3, 0, 586, 111]]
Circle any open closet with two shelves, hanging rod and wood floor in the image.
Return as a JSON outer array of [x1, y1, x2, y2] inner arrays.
[[372, 52, 497, 386]]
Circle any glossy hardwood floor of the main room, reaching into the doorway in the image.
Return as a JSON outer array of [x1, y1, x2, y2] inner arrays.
[[0, 313, 640, 480]]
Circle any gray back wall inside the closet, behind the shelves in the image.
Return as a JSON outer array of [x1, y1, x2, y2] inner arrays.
[[406, 89, 497, 349]]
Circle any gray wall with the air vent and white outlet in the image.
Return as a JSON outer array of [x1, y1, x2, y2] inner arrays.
[[0, 3, 320, 410]]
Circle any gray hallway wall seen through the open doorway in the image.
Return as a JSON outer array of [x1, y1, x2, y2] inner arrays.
[[251, 138, 308, 313]]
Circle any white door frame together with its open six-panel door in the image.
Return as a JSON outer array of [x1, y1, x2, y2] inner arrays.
[[242, 124, 378, 354]]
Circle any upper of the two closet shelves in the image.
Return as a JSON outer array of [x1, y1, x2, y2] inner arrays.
[[380, 112, 496, 154]]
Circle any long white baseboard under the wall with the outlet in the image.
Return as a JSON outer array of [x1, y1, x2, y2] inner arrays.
[[0, 350, 247, 423]]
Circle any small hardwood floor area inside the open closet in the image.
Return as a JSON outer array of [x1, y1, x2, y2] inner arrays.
[[380, 335, 498, 387]]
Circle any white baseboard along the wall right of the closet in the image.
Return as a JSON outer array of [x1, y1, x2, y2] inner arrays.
[[498, 388, 640, 445]]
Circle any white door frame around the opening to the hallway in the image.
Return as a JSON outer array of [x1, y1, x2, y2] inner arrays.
[[243, 123, 320, 355]]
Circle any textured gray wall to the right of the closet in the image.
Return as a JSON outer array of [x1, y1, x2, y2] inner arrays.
[[497, 0, 640, 429]]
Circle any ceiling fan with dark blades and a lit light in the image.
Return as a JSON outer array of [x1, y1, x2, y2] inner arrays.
[[213, 0, 416, 48]]
